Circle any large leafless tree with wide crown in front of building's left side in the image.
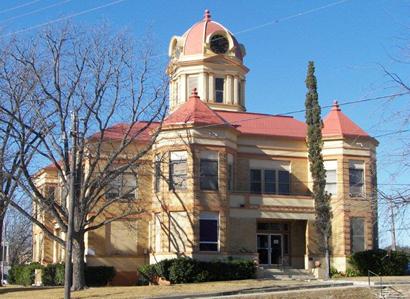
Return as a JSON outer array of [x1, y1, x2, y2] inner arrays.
[[0, 26, 168, 290]]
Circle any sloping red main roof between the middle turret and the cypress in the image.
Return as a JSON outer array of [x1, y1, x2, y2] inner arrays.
[[217, 111, 306, 139]]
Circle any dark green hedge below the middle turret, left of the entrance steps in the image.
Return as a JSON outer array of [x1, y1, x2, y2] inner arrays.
[[138, 257, 256, 284]]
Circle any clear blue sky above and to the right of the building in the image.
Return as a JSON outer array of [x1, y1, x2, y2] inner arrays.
[[0, 0, 410, 245]]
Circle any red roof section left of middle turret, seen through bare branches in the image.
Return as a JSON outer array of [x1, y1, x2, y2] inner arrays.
[[90, 121, 159, 142]]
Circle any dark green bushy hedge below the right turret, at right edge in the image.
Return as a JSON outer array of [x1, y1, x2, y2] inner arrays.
[[349, 249, 410, 276]]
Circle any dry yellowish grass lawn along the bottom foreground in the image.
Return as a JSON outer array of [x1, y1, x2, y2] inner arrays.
[[0, 280, 373, 299]]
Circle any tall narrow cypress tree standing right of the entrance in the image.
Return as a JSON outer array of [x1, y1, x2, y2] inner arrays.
[[305, 61, 332, 279]]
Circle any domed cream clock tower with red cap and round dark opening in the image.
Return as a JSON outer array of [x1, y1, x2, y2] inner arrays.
[[167, 10, 249, 112]]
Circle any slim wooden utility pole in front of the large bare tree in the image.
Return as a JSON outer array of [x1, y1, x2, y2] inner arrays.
[[64, 110, 78, 299]]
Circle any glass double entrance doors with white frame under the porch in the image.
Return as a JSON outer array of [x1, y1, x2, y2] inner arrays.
[[257, 234, 282, 265]]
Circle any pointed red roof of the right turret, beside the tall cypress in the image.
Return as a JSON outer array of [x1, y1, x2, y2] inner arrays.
[[322, 101, 369, 137]]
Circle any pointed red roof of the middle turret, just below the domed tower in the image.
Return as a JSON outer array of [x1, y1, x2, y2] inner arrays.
[[164, 88, 226, 126]]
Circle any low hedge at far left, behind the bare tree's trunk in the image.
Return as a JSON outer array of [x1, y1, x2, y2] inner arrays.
[[8, 263, 115, 286]]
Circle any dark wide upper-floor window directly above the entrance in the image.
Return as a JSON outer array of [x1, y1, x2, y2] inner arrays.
[[250, 169, 290, 195]]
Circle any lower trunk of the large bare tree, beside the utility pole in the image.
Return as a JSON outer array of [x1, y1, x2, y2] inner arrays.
[[71, 232, 86, 291]]
